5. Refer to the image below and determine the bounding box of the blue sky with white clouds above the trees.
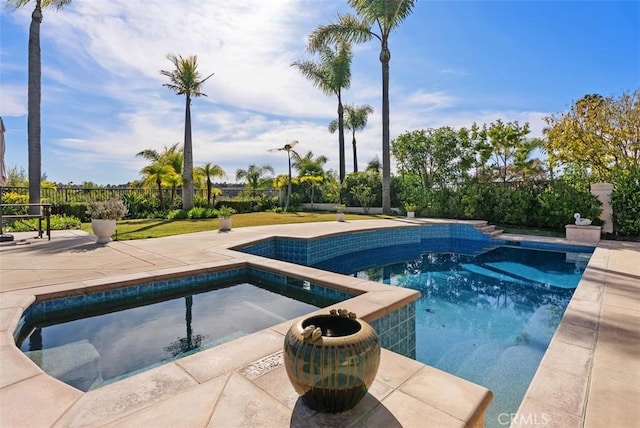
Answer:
[0,0,640,184]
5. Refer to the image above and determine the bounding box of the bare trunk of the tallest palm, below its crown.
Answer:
[380,43,391,215]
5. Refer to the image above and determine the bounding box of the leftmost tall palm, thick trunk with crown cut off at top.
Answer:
[7,0,71,214]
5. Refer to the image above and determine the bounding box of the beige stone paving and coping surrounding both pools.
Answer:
[0,219,640,426]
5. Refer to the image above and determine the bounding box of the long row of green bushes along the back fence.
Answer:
[2,170,640,238]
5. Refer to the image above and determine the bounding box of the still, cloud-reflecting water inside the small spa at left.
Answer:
[17,279,336,391]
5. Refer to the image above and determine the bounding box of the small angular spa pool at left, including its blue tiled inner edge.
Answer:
[16,269,351,391]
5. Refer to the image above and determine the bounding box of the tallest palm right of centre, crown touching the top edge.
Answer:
[308,0,416,214]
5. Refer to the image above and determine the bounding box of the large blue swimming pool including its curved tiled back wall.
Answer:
[240,225,593,426]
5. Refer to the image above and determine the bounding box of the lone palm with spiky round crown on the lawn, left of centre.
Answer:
[160,54,213,210]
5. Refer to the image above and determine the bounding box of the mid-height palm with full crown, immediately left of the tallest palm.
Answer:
[291,40,353,182]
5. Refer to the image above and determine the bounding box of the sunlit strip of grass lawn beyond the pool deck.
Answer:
[82,212,380,241]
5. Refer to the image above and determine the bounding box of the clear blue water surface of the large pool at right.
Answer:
[323,242,590,426]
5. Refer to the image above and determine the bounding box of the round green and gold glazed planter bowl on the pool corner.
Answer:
[284,309,380,413]
